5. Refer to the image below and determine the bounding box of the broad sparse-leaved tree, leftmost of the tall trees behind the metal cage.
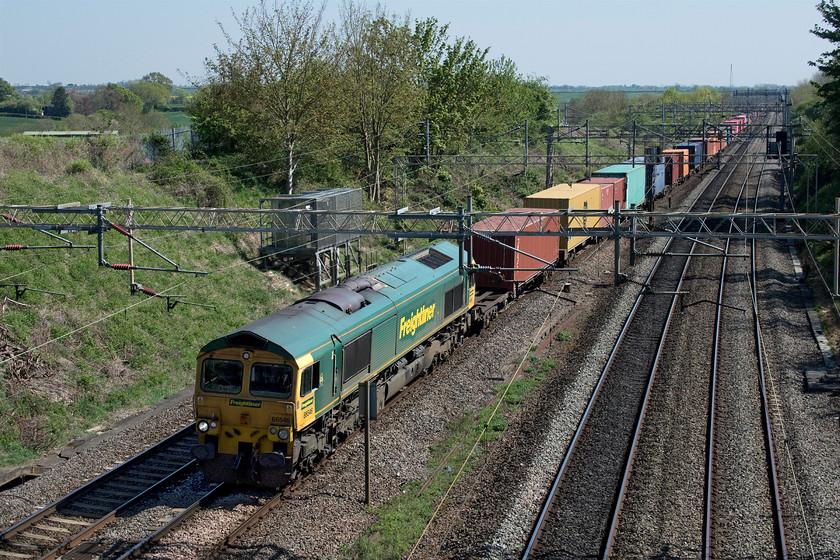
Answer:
[197,0,336,193]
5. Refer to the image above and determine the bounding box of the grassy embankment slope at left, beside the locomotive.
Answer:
[0,136,300,466]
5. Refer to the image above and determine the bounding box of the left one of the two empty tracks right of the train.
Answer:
[523,133,747,558]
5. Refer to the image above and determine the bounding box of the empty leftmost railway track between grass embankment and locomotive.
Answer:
[0,424,196,560]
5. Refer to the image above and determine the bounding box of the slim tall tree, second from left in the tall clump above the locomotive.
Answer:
[340,2,422,202]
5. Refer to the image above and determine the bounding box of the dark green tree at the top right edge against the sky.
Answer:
[809,0,840,134]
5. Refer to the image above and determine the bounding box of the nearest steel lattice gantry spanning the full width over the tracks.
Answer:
[0,205,840,241]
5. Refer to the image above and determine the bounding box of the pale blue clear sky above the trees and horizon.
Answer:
[0,0,829,87]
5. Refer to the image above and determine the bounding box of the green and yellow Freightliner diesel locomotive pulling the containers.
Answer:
[193,242,475,487]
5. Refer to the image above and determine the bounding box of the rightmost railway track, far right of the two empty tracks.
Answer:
[702,143,788,559]
